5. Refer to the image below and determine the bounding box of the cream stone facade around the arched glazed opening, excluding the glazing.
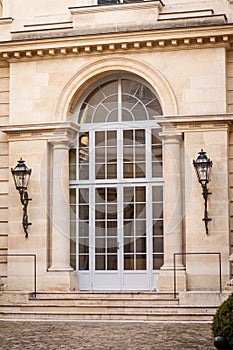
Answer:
[0,0,233,291]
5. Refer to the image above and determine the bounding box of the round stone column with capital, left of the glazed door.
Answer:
[49,124,79,271]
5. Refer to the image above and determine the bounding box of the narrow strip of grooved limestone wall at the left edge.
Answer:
[0,63,9,288]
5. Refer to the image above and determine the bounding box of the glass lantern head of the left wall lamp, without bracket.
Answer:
[11,158,32,191]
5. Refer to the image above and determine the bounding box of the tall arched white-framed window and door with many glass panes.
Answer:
[70,75,163,290]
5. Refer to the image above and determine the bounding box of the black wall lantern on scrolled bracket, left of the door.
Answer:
[11,158,32,238]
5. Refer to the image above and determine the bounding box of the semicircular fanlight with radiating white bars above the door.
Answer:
[74,75,162,124]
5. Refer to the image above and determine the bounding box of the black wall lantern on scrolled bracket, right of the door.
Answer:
[193,149,212,235]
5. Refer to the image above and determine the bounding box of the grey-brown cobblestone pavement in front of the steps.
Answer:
[0,321,215,350]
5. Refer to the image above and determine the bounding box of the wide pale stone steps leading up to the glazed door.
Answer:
[0,292,217,322]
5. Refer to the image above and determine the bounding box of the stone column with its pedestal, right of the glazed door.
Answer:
[158,131,185,291]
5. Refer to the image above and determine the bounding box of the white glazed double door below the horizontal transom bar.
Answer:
[76,182,162,291]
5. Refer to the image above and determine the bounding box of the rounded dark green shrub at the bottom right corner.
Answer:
[212,294,233,349]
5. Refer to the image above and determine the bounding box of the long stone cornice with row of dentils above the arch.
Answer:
[0,25,233,61]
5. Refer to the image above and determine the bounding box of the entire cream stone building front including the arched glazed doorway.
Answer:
[0,0,233,291]
